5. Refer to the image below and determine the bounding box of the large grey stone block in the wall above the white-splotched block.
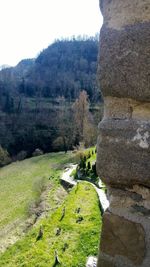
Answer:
[98,23,150,102]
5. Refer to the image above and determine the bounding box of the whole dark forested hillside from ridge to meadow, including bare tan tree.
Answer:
[0,35,101,161]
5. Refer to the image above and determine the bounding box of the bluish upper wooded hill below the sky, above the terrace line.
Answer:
[0,37,100,102]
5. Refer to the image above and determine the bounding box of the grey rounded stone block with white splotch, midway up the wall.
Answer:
[97,119,150,187]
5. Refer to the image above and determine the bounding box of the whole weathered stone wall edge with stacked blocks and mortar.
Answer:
[97,0,150,267]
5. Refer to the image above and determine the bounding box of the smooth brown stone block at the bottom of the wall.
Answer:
[101,213,146,266]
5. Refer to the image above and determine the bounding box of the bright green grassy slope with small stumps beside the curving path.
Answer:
[0,182,101,267]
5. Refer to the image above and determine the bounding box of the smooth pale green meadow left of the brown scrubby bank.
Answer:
[0,153,73,253]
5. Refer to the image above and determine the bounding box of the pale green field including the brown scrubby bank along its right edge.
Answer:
[0,152,77,251]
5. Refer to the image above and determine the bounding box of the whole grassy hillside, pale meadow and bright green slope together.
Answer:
[0,153,101,267]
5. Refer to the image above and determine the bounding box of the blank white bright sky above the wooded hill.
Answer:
[0,0,102,66]
